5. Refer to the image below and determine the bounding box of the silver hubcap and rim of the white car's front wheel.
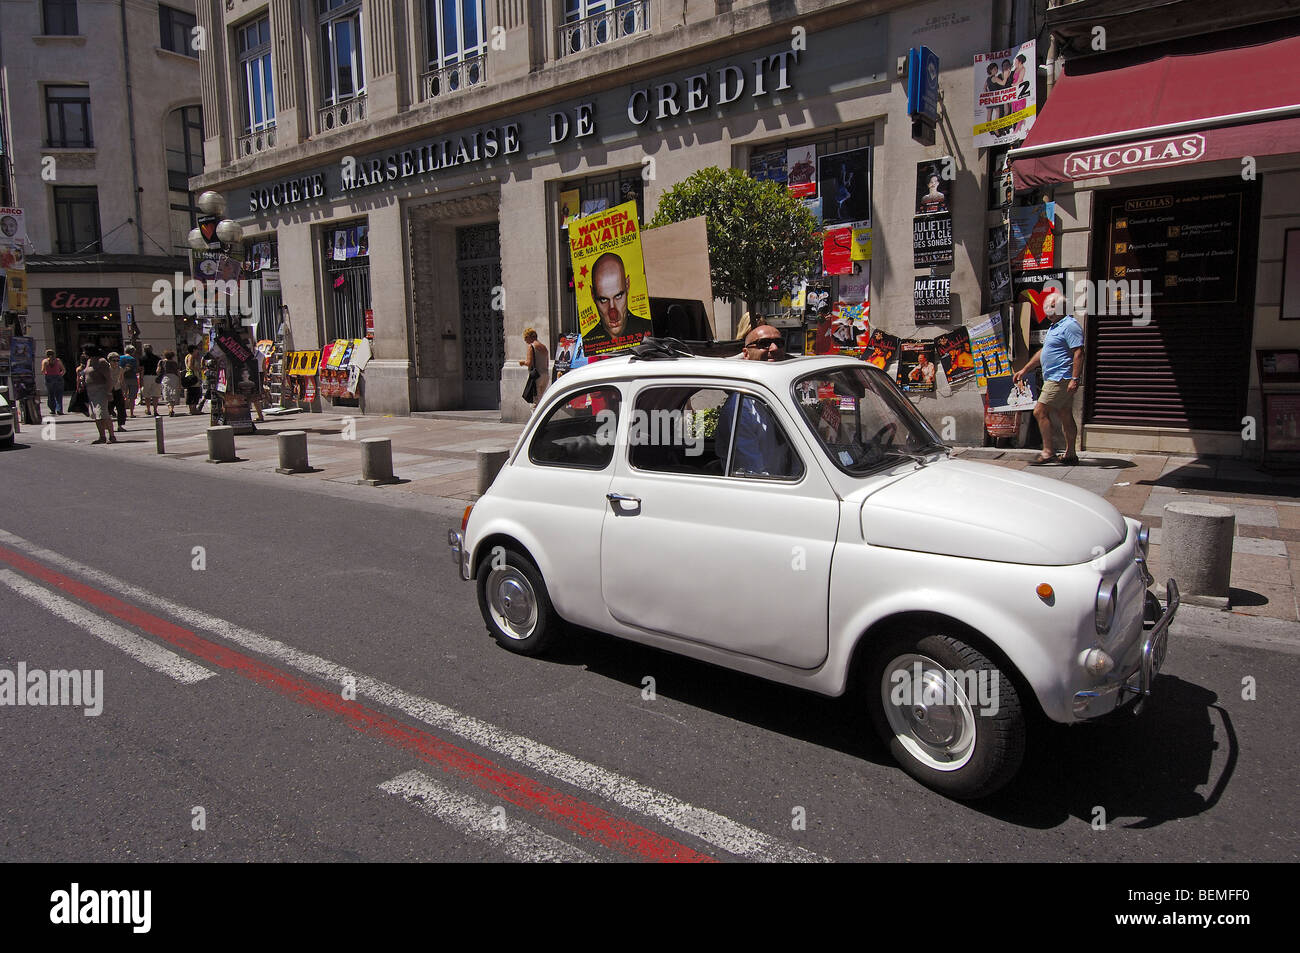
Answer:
[880,655,975,771]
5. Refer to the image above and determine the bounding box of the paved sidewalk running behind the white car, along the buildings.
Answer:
[18,411,1300,623]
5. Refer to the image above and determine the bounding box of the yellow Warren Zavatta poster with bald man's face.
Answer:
[569,202,651,360]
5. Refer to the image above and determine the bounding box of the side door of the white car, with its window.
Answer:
[601,381,840,668]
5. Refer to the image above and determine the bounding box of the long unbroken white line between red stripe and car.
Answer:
[0,529,828,863]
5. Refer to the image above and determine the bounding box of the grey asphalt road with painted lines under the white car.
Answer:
[0,443,1300,862]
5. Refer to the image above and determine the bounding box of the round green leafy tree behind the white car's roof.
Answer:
[649,165,822,321]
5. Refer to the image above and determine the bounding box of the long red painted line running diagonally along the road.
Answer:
[0,546,716,863]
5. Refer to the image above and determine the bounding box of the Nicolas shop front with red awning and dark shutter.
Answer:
[1011,31,1300,459]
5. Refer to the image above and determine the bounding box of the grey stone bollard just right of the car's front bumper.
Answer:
[1160,501,1236,608]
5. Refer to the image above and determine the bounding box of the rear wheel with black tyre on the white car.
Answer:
[478,547,560,655]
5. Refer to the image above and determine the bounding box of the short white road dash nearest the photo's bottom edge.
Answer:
[380,771,595,863]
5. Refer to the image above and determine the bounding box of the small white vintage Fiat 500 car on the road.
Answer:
[449,355,1178,798]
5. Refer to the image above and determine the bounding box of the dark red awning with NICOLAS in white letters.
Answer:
[1010,36,1300,189]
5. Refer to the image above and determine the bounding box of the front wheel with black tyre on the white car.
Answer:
[865,634,1026,800]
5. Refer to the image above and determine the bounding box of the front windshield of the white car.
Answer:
[794,365,945,476]
